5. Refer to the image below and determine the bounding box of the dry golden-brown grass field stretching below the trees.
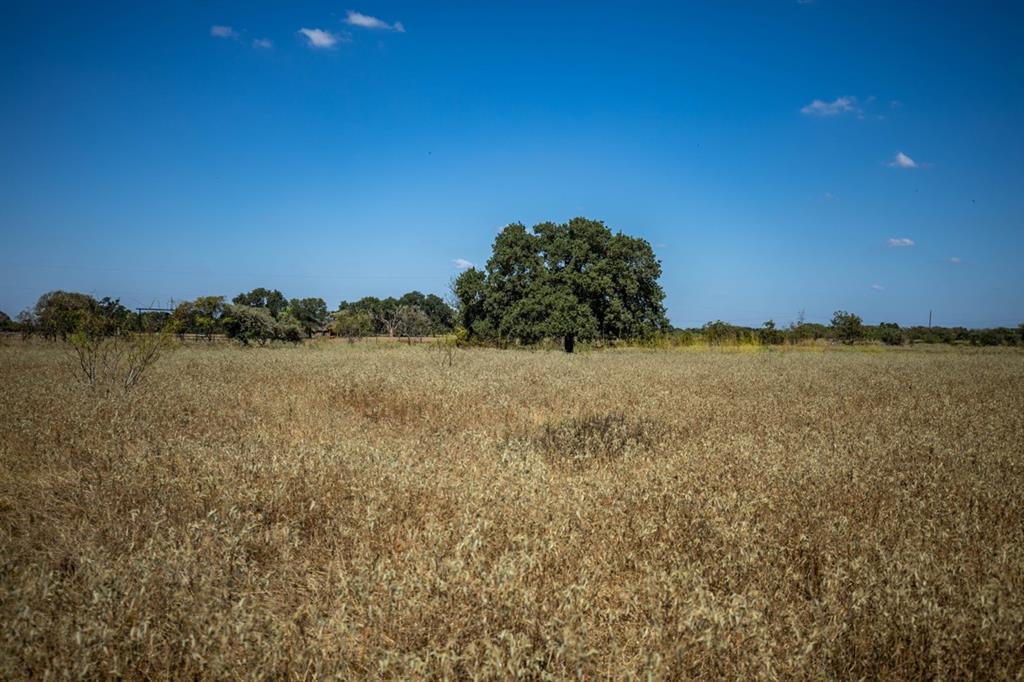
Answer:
[0,342,1024,679]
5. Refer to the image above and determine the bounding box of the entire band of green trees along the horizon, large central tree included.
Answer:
[0,284,1024,350]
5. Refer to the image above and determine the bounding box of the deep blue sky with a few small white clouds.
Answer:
[0,0,1024,326]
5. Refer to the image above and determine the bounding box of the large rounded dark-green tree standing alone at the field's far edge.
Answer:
[453,218,668,352]
